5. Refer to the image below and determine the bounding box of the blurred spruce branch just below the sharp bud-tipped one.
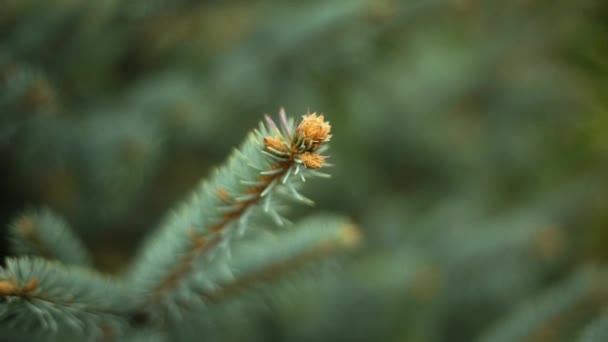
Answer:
[196,215,361,303]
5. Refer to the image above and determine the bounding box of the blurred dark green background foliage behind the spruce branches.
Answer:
[0,0,608,341]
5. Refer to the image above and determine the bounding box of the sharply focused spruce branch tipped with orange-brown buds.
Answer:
[129,109,338,316]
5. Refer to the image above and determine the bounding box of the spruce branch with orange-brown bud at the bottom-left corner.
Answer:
[0,257,135,337]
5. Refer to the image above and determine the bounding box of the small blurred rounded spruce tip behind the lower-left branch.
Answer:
[10,209,91,266]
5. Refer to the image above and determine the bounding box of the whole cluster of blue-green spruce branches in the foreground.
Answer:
[0,110,359,340]
